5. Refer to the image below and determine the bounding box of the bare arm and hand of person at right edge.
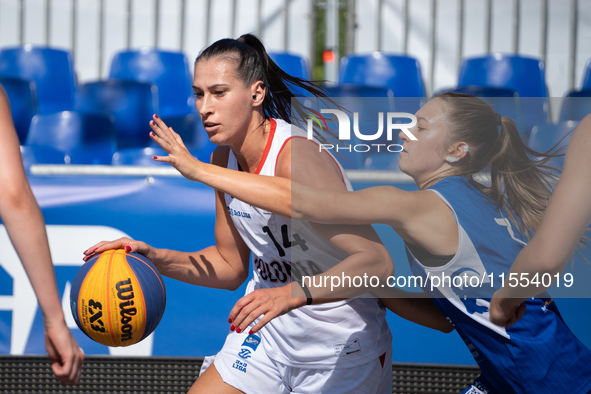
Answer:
[490,115,591,327]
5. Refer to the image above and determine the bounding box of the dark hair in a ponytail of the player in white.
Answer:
[195,34,334,142]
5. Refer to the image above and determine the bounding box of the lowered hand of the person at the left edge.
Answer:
[44,319,84,385]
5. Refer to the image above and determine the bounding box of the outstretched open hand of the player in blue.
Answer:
[150,114,202,181]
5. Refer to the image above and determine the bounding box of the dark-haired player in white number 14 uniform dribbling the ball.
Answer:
[86,35,449,394]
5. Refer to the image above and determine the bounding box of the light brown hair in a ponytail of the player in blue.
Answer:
[437,93,562,239]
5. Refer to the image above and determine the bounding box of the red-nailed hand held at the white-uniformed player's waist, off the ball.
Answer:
[228,285,306,334]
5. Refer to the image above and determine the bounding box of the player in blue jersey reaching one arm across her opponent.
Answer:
[154,94,591,394]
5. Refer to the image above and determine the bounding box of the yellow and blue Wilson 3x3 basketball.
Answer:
[70,249,166,346]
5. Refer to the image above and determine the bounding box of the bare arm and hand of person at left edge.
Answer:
[0,85,84,385]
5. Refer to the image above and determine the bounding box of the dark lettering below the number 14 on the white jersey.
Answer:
[254,257,323,283]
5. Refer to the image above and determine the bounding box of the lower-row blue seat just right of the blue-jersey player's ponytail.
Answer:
[527,120,579,168]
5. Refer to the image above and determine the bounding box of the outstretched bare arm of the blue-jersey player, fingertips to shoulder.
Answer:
[150,115,434,228]
